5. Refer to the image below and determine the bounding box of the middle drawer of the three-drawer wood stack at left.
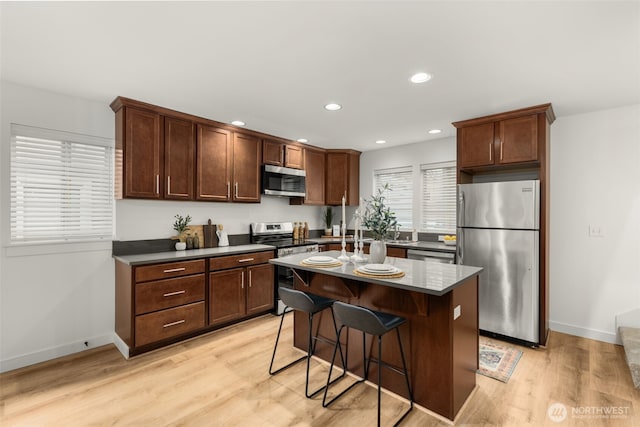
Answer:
[135,274,205,314]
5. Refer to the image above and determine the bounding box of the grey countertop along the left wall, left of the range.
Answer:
[114,245,276,265]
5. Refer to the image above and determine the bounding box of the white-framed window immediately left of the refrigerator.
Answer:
[420,162,457,234]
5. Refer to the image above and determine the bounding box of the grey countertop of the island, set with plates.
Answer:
[269,251,482,296]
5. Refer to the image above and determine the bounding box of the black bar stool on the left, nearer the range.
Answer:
[269,287,346,398]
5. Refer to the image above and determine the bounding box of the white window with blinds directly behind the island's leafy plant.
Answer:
[373,166,415,230]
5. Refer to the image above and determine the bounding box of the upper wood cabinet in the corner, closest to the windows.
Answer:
[325,150,360,206]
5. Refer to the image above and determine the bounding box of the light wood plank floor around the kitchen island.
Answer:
[0,315,640,427]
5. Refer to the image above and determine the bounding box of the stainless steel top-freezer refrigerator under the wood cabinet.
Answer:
[457,180,540,345]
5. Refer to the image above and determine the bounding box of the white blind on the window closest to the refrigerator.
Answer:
[420,163,456,233]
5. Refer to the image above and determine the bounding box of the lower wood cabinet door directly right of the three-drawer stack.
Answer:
[209,268,246,325]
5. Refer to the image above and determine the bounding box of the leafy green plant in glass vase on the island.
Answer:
[362,185,398,264]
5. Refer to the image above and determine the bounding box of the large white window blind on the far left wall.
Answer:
[10,124,114,244]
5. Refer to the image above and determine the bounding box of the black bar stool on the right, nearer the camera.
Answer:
[322,301,413,426]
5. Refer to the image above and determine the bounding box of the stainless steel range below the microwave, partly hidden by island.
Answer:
[249,222,318,314]
